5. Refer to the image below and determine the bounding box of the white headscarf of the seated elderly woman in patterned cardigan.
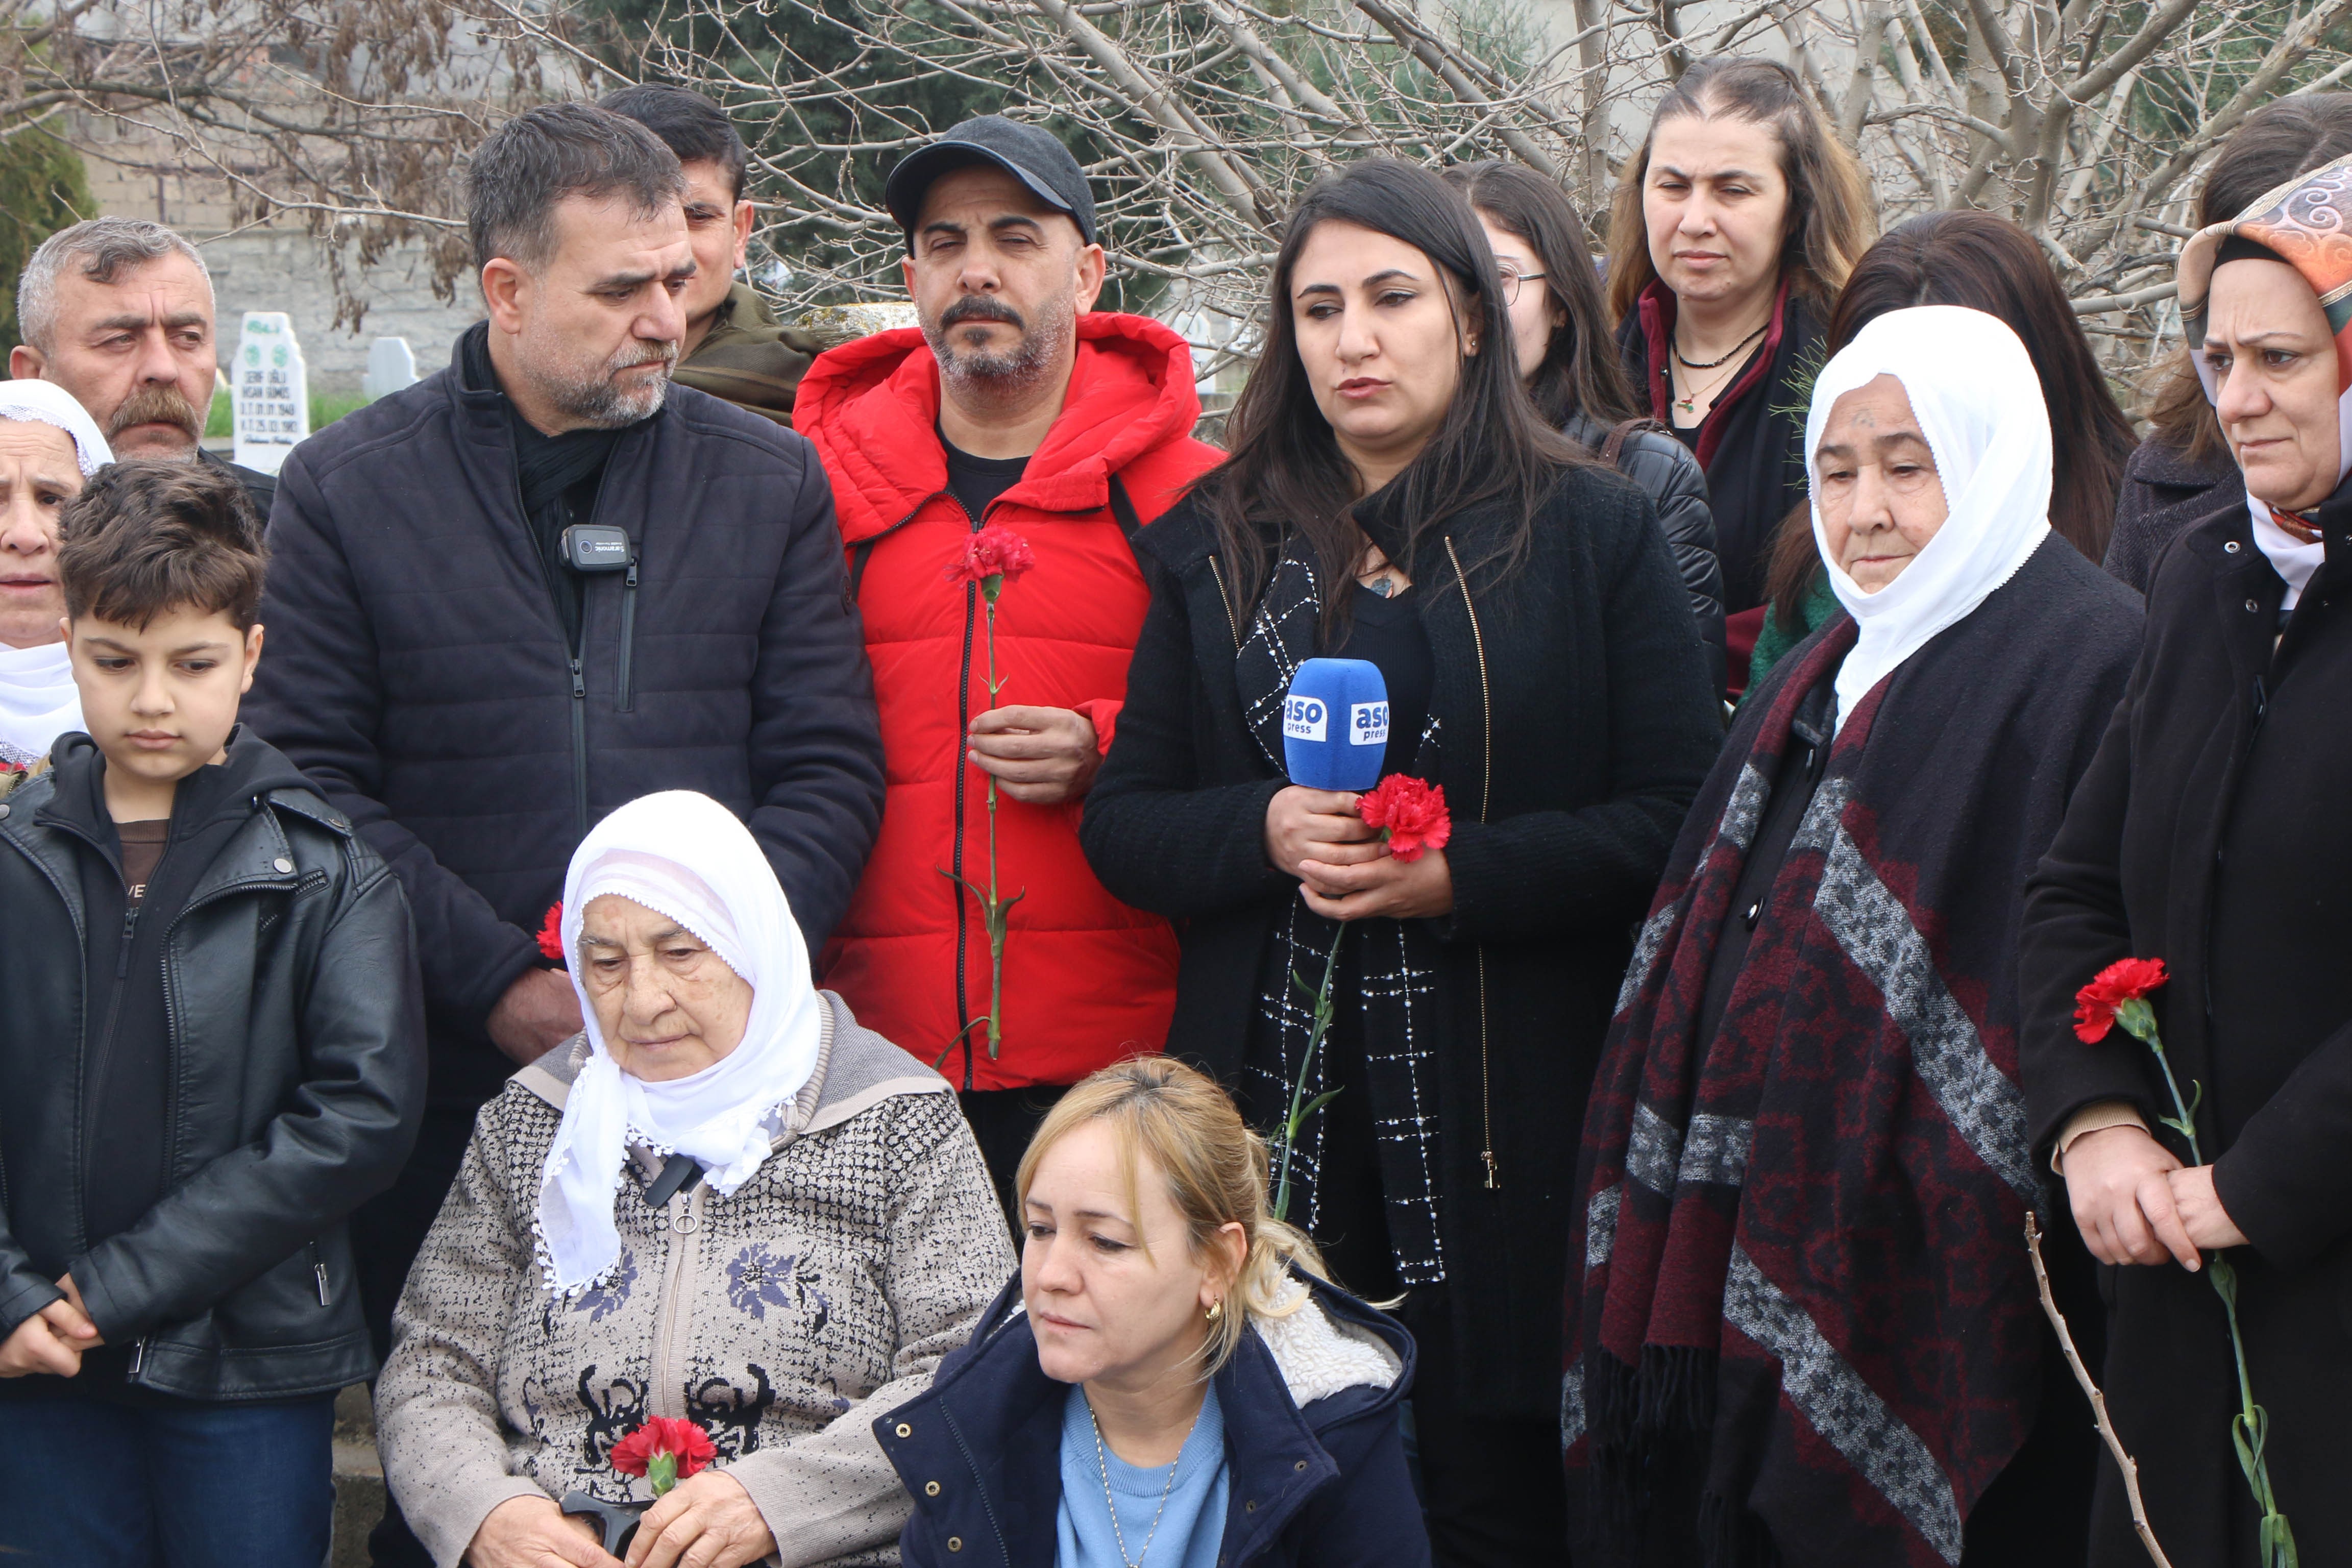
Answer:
[538,790,825,1295]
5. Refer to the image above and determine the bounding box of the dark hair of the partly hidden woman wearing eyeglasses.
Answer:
[1444,158,1649,428]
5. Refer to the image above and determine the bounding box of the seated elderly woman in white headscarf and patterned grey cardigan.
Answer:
[376,792,1014,1568]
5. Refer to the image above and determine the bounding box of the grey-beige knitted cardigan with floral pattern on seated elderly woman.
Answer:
[376,992,1014,1568]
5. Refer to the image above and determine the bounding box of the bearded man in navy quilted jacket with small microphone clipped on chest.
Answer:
[249,104,882,1401]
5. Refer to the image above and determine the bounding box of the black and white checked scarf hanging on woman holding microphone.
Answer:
[1235,538,1447,1286]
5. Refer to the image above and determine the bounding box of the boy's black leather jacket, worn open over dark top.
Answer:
[0,731,426,1401]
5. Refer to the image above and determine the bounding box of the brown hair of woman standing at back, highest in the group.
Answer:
[1609,54,1877,322]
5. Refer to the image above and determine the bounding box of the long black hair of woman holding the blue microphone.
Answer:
[1192,158,1583,632]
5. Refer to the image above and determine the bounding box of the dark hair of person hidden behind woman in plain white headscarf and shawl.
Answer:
[1764,209,2140,630]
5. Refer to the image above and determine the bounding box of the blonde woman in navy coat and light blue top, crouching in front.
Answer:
[875,1056,1430,1568]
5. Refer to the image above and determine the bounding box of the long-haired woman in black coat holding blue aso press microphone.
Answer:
[1082,160,1719,1563]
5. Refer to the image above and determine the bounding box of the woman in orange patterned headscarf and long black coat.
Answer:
[2020,158,2352,1568]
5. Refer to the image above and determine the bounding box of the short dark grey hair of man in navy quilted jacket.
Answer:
[465,104,687,271]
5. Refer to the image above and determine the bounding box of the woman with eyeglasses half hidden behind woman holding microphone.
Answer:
[1444,160,1724,694]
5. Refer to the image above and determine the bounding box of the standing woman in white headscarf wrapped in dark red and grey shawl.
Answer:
[1562,306,2140,1568]
